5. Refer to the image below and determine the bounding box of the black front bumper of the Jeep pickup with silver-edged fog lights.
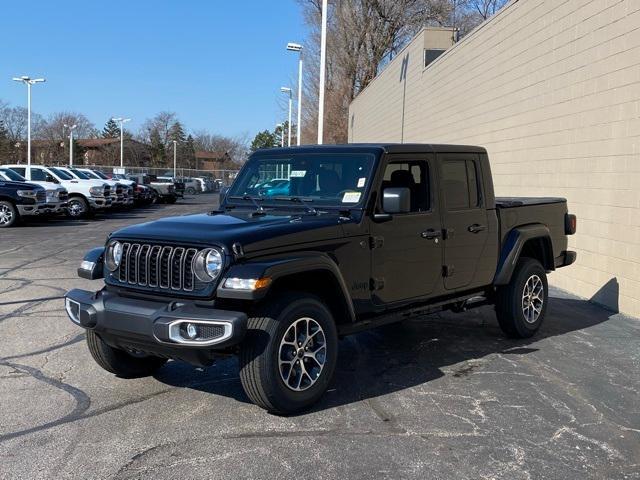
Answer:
[65,289,247,365]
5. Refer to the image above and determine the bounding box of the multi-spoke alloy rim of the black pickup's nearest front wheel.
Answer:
[278,317,327,392]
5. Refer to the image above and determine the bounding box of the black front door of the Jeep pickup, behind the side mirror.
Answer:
[371,154,442,305]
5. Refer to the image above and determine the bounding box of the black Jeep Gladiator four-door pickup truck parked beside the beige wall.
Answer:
[65,144,576,414]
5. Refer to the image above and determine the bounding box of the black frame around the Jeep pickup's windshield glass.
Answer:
[221,149,381,211]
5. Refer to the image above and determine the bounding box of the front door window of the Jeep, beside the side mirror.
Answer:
[382,161,431,213]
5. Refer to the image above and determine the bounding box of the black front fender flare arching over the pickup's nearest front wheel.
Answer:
[216,252,356,321]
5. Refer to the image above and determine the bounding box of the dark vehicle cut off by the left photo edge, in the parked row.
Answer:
[0,176,48,228]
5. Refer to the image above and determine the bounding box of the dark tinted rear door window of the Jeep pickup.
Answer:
[442,160,480,210]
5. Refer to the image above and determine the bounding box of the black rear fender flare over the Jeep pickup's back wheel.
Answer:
[493,224,555,285]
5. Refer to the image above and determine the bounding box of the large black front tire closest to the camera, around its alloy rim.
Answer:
[240,293,338,415]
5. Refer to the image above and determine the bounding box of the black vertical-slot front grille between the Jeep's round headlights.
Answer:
[113,243,199,292]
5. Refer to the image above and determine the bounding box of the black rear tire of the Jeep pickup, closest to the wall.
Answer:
[496,257,549,338]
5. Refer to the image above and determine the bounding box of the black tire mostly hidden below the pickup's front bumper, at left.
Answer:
[87,330,167,378]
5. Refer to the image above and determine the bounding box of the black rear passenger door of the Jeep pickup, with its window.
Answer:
[438,153,488,290]
